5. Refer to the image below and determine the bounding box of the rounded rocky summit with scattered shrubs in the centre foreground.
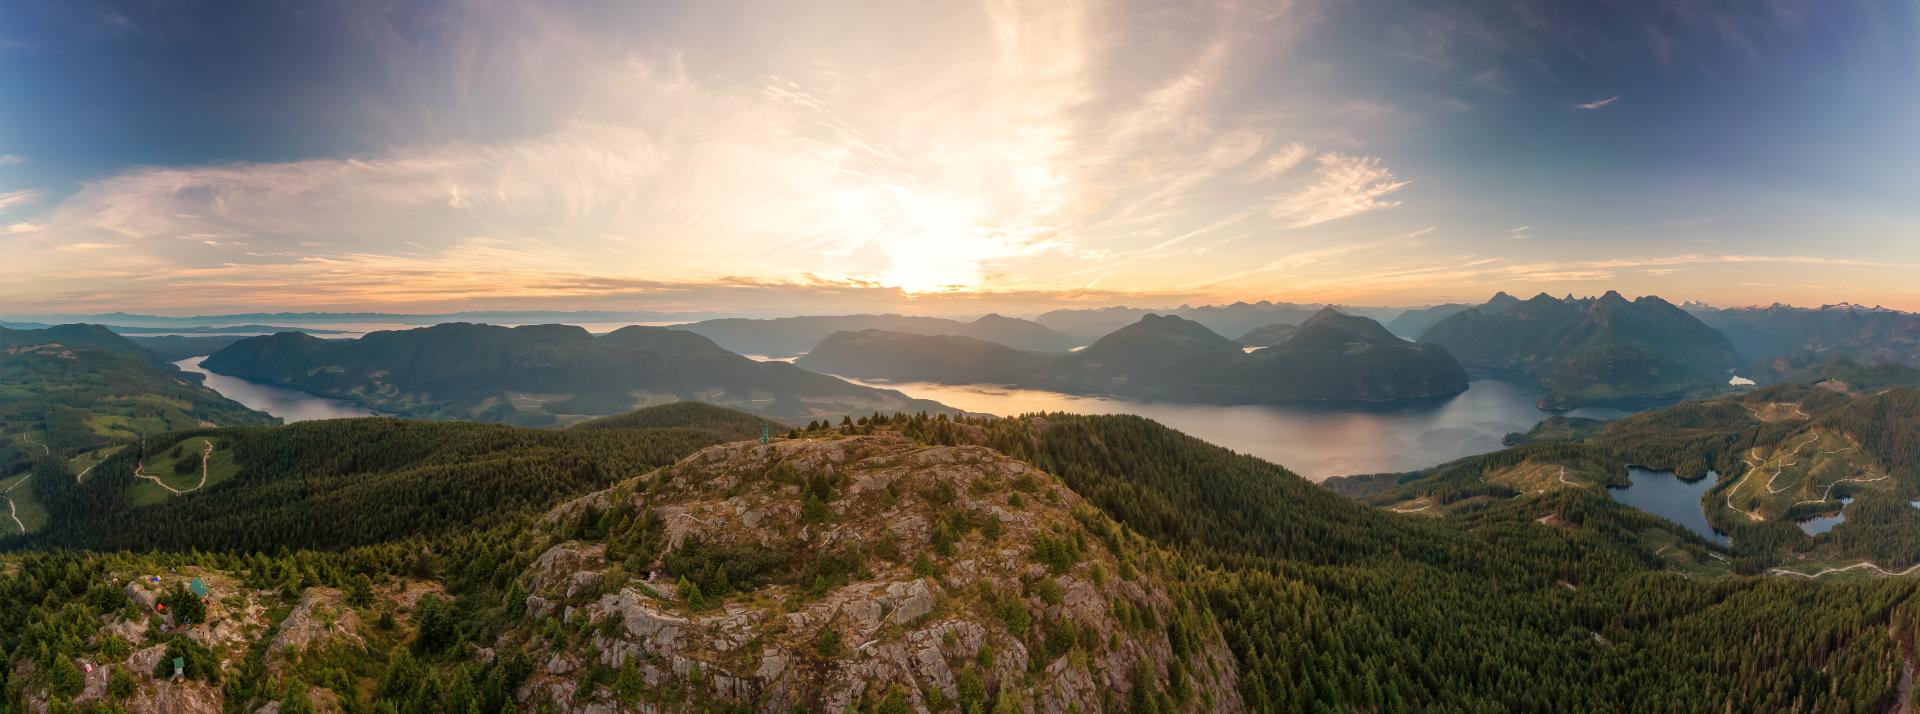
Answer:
[495,436,1240,712]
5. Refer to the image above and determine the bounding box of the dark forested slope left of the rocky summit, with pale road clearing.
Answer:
[13,405,785,551]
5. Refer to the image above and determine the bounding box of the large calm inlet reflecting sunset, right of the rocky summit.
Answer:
[837,380,1624,480]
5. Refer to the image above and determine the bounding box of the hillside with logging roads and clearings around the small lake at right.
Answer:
[1327,378,1920,570]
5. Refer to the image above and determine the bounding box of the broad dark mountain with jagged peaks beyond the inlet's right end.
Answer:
[1421,290,1738,409]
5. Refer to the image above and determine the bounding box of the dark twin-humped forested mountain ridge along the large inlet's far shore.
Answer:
[799,309,1467,403]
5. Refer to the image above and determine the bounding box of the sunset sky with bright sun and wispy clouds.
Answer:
[0,0,1920,315]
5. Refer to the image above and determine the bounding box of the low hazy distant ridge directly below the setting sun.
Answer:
[674,315,1079,357]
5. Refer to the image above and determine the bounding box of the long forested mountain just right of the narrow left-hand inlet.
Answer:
[202,322,950,426]
